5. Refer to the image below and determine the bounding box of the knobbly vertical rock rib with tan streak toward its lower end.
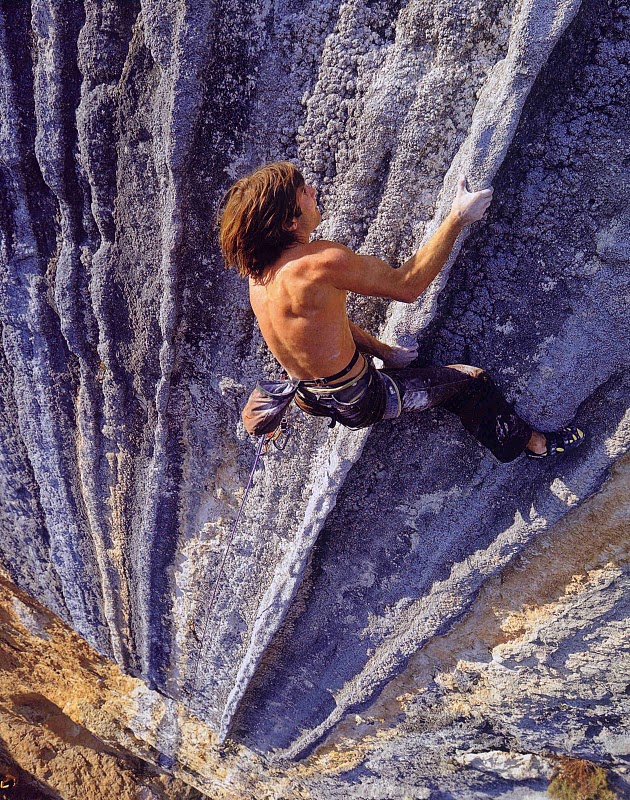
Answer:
[74,3,143,669]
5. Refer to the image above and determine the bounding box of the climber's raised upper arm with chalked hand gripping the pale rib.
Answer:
[322,175,493,303]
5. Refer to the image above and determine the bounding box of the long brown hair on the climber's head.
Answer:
[217,161,304,278]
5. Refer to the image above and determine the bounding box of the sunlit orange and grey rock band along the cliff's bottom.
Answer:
[0,457,630,800]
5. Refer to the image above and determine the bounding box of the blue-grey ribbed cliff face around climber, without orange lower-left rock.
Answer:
[0,0,630,798]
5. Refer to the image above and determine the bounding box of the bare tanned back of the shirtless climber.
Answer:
[249,242,360,379]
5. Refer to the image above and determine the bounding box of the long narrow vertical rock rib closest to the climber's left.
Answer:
[131,2,222,681]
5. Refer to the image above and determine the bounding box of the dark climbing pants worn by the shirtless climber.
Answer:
[297,363,532,463]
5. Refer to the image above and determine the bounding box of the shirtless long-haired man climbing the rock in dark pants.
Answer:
[220,162,584,462]
